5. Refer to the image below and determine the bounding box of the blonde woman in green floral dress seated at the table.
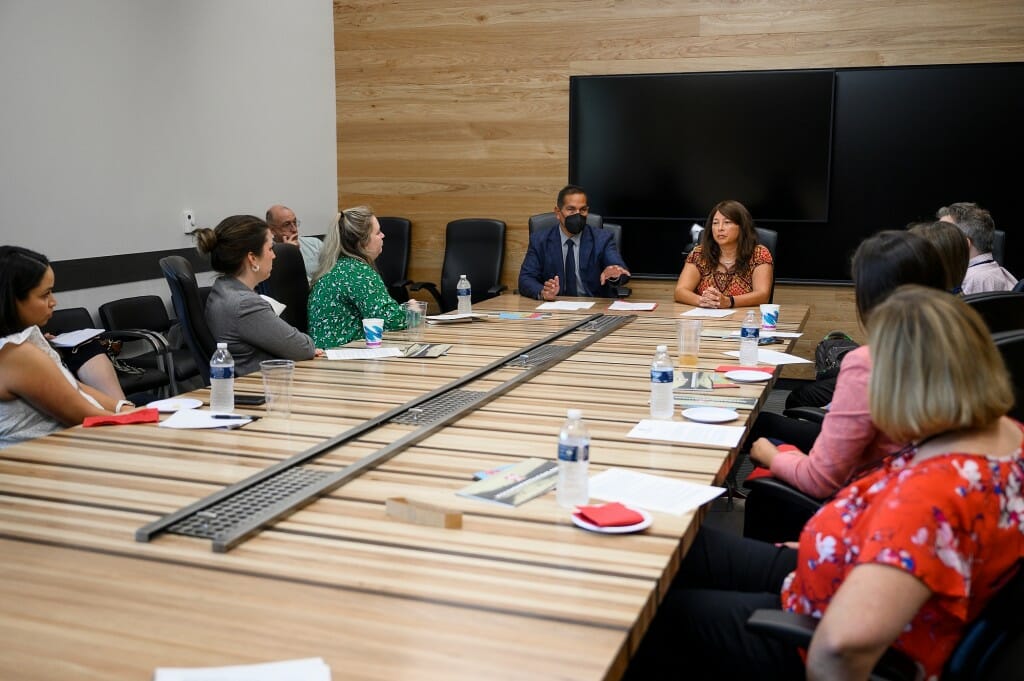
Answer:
[309,206,406,348]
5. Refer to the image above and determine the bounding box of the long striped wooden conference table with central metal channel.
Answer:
[0,294,808,681]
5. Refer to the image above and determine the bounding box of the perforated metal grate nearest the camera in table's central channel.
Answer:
[168,467,331,539]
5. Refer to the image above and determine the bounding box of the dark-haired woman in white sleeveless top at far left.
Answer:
[0,246,130,448]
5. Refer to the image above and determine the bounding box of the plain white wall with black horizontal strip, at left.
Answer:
[0,0,338,317]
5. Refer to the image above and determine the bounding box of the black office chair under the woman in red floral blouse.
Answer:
[746,566,1024,681]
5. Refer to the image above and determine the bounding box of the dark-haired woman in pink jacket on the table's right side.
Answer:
[751,230,946,499]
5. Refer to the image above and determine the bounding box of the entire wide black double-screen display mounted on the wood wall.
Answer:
[569,62,1024,282]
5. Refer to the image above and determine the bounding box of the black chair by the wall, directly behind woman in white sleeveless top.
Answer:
[42,307,177,396]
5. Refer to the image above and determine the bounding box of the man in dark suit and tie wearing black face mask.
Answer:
[519,184,630,300]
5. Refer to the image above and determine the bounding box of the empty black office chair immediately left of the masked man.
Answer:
[409,218,506,312]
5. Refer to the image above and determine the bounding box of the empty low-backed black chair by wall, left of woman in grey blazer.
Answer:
[99,296,199,392]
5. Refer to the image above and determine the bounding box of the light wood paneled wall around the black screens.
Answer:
[334,0,1024,315]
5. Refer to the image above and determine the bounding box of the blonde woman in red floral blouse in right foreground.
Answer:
[627,286,1024,679]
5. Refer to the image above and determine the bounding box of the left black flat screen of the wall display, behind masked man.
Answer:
[569,71,835,223]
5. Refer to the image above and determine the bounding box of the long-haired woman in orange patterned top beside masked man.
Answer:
[675,199,774,307]
